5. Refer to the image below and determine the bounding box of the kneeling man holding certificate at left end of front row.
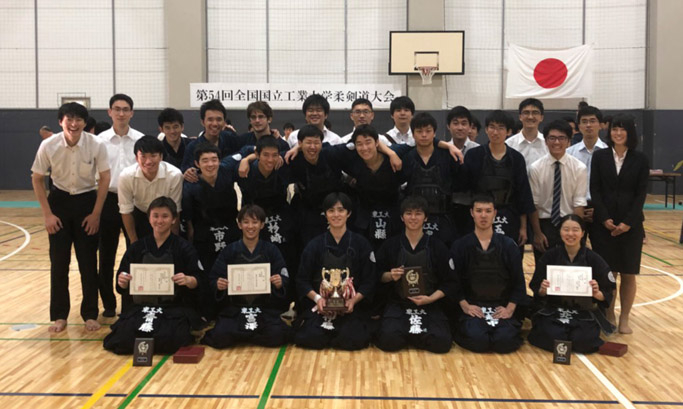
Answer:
[104,196,204,355]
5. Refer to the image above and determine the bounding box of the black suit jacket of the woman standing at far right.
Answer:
[590,148,650,227]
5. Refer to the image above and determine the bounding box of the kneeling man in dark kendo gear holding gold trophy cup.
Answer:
[294,192,376,350]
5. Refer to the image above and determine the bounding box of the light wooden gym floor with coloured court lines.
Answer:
[0,191,683,409]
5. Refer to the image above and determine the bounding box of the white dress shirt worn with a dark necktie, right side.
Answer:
[529,153,588,219]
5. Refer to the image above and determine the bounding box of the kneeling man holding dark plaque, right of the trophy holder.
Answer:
[375,196,455,353]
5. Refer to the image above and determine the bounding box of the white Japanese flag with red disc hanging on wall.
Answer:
[505,44,593,98]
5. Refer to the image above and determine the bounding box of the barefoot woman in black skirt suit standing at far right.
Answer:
[590,114,650,334]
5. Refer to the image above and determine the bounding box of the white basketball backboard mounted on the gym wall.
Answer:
[389,31,465,75]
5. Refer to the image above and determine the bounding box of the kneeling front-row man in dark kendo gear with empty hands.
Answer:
[451,196,526,353]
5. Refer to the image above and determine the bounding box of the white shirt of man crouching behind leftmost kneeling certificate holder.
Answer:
[119,162,183,214]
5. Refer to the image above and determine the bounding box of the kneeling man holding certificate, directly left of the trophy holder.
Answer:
[202,205,292,348]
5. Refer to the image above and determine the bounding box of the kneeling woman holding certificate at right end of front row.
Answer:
[528,214,616,353]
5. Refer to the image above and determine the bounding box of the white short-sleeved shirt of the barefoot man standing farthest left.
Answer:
[31,132,109,195]
